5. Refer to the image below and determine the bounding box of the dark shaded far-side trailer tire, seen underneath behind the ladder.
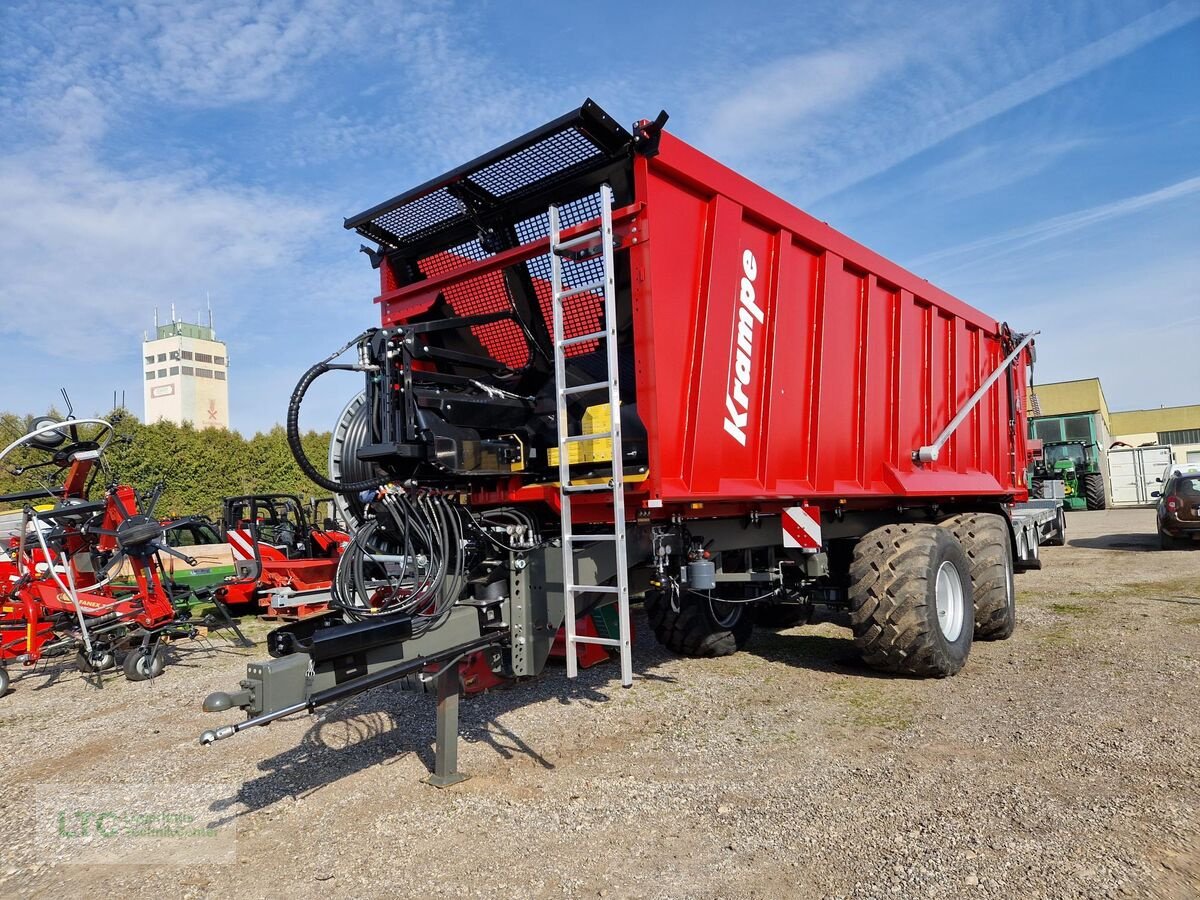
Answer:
[643,589,754,656]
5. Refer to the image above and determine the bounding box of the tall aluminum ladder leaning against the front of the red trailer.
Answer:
[550,185,634,688]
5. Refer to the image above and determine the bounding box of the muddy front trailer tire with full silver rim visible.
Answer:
[850,524,974,678]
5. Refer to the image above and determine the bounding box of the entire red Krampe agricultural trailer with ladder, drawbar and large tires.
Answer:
[203,101,1061,784]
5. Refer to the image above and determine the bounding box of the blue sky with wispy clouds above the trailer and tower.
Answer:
[0,0,1200,432]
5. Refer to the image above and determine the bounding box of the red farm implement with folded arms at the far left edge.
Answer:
[0,418,245,695]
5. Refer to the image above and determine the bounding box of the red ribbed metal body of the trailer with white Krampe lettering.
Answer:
[364,103,1027,518]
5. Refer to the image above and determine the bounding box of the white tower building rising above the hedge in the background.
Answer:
[142,313,229,428]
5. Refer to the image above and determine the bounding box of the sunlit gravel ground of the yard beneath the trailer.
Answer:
[0,510,1200,898]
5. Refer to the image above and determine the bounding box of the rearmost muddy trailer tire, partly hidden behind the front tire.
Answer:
[941,512,1016,641]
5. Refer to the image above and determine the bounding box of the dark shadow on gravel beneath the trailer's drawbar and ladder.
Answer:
[202,610,676,827]
